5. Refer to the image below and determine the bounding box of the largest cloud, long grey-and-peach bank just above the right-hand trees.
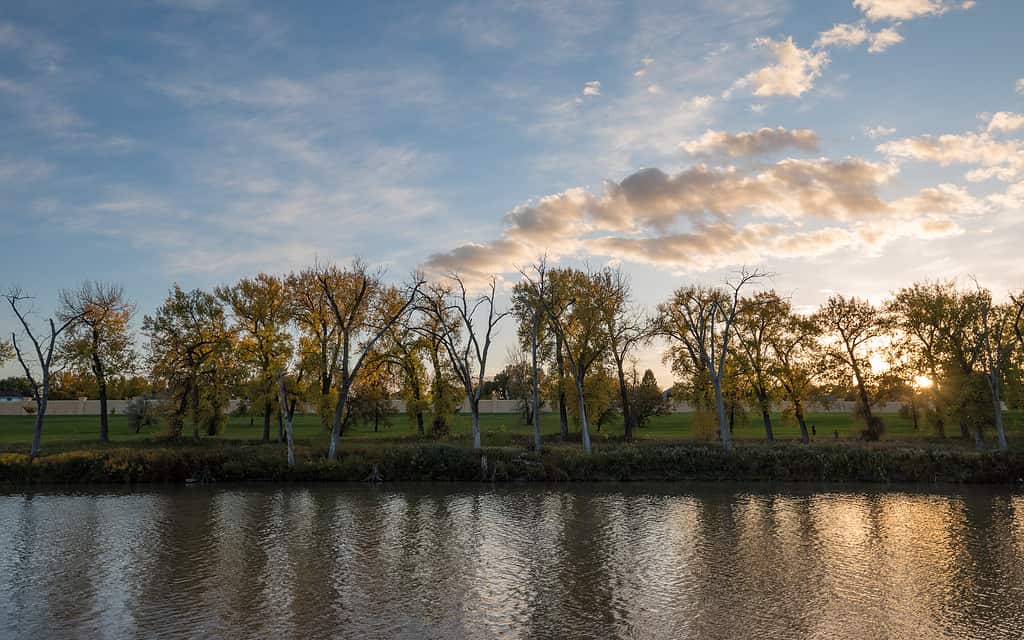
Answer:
[425,153,970,278]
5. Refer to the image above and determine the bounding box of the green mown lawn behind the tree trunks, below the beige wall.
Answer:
[0,412,1024,451]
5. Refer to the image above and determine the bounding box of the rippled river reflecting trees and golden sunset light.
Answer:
[0,483,1024,640]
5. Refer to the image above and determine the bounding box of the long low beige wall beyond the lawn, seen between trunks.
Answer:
[0,398,900,416]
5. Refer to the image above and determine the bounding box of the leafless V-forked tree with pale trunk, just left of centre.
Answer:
[420,273,509,450]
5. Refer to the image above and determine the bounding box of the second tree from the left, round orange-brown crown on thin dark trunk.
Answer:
[57,281,136,442]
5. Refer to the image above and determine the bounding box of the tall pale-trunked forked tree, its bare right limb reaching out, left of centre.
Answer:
[316,260,426,460]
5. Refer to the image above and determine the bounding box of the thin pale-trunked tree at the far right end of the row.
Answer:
[974,281,1024,451]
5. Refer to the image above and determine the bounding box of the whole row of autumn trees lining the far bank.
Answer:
[6,259,1024,459]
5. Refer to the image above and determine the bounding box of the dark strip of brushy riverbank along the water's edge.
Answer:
[0,442,1024,485]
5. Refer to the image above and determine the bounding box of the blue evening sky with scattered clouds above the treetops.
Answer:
[0,0,1024,378]
